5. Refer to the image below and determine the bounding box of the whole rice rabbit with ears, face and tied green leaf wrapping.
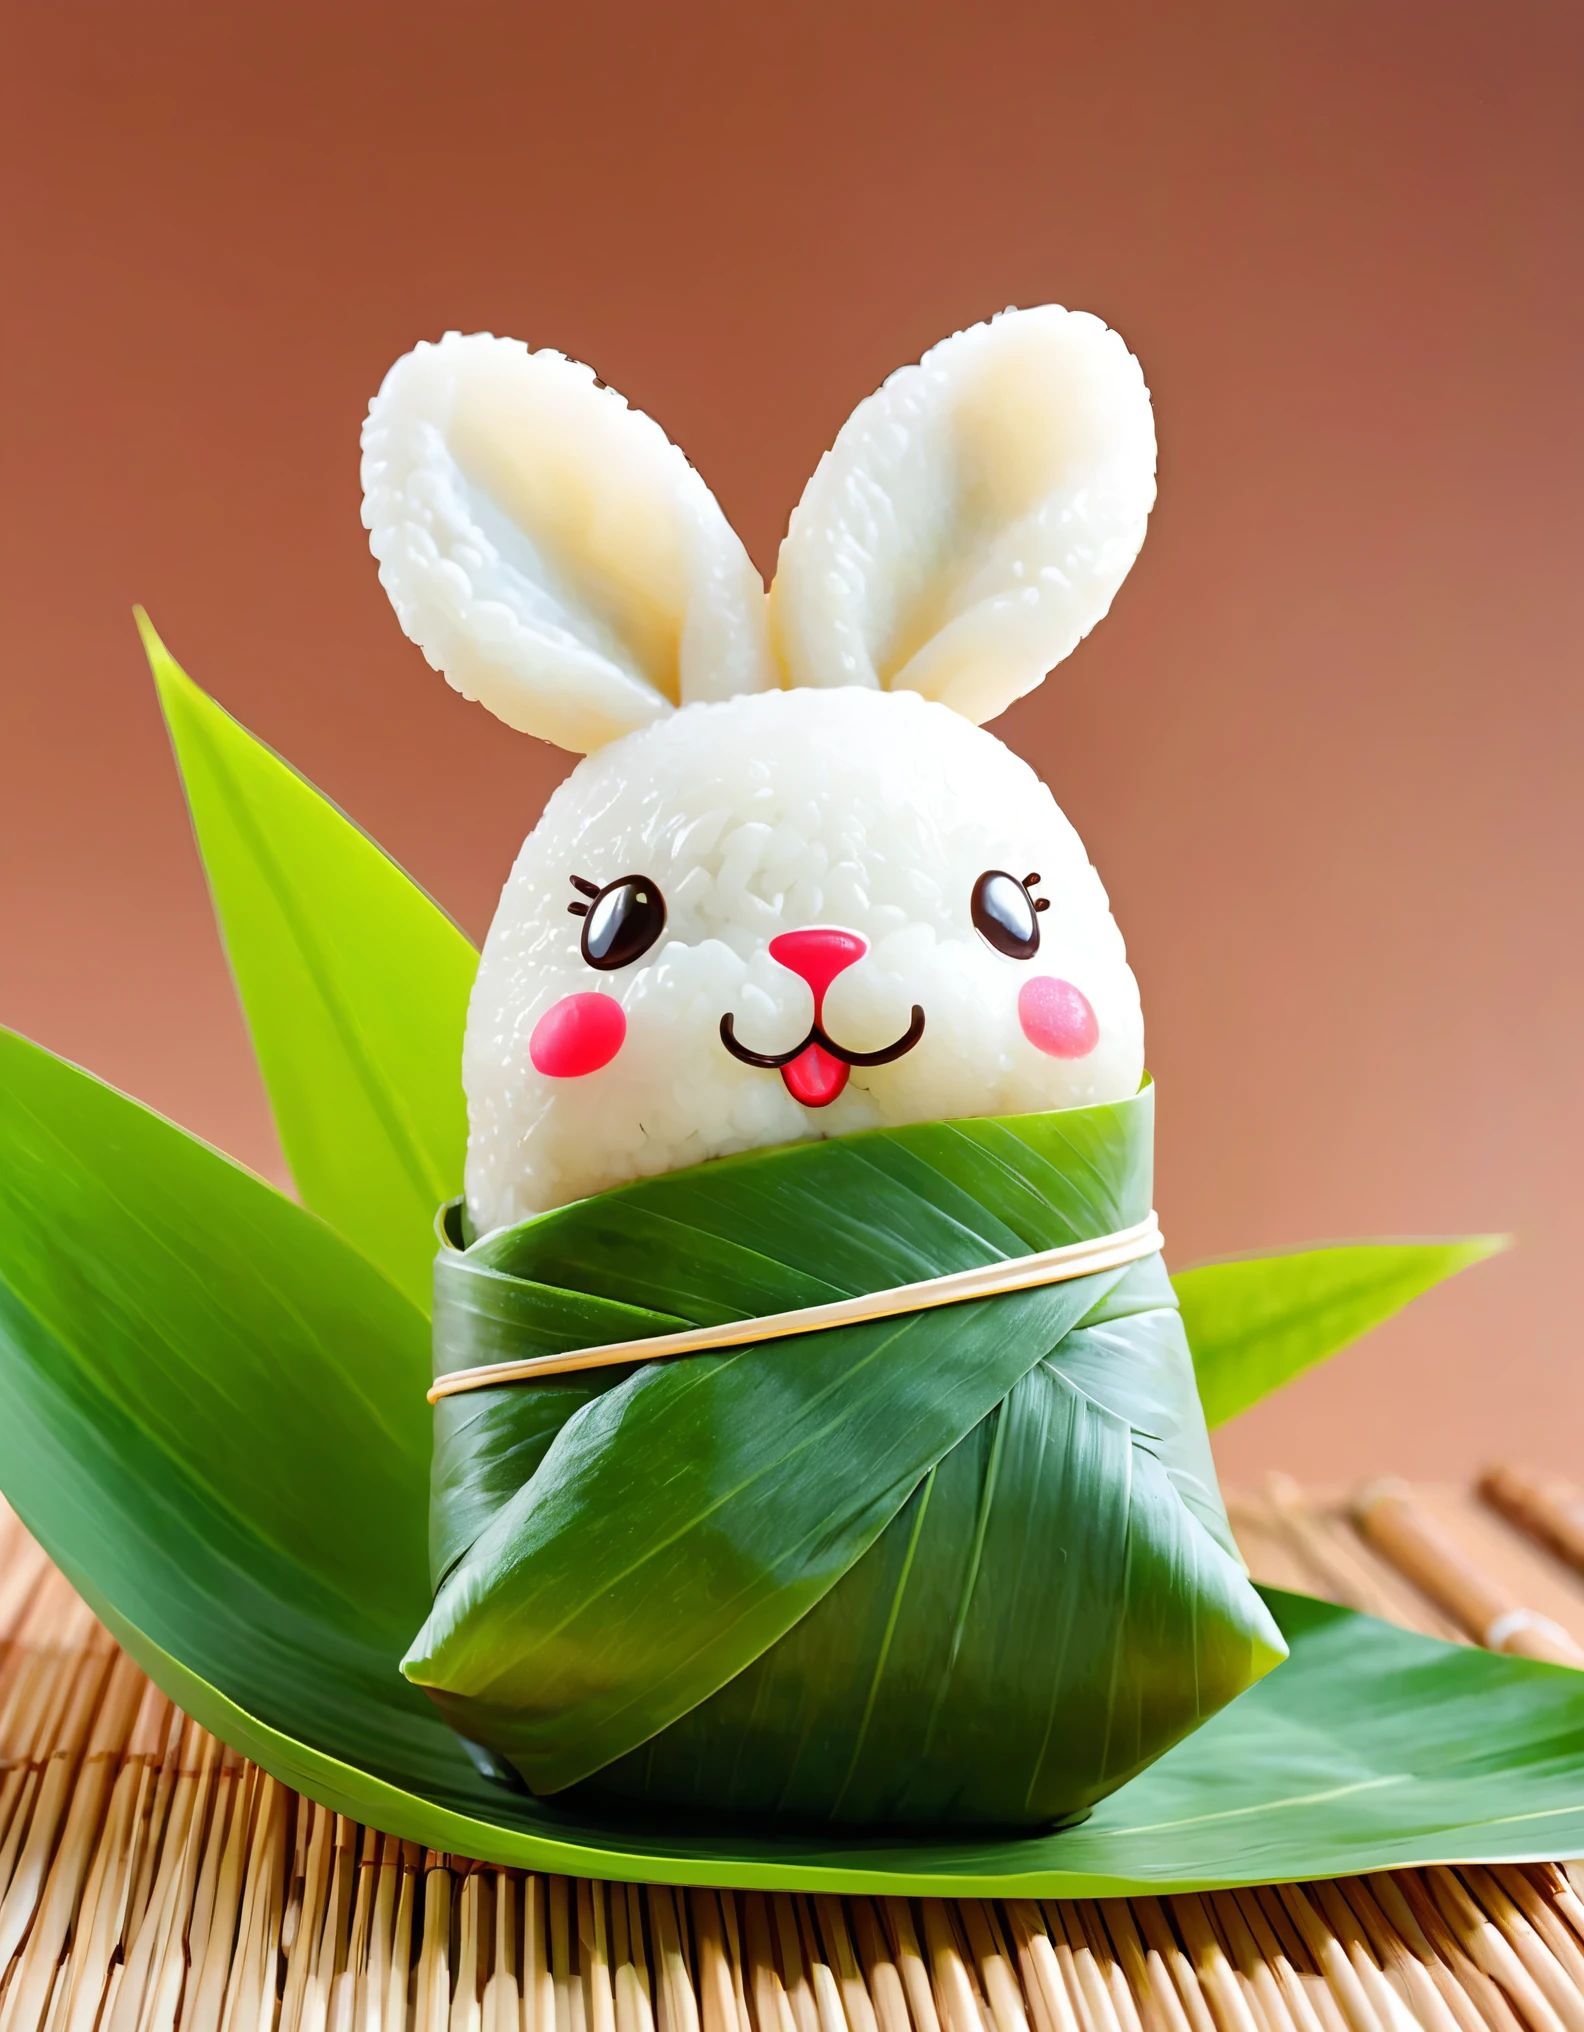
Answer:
[364,321,1283,1829]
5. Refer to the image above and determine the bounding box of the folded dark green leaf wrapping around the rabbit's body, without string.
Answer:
[404,1087,1285,1827]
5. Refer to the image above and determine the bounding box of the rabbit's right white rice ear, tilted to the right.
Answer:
[770,305,1156,721]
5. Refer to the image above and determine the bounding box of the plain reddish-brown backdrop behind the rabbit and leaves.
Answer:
[0,0,1584,1473]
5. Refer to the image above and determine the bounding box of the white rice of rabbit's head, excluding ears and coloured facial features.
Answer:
[463,687,1143,1233]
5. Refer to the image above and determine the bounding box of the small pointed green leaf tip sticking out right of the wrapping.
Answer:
[1172,1235,1507,1426]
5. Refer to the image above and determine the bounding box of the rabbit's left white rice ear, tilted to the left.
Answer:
[364,331,776,754]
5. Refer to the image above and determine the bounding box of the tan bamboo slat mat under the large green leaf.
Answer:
[0,1477,1584,2032]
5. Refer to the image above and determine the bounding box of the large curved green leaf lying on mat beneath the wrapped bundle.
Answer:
[0,1034,1584,1898]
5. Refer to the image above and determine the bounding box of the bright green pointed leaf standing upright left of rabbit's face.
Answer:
[138,610,477,1313]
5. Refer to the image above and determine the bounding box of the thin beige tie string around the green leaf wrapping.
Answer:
[428,1209,1162,1404]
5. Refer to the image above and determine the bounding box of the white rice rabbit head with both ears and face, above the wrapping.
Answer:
[364,305,1156,1231]
